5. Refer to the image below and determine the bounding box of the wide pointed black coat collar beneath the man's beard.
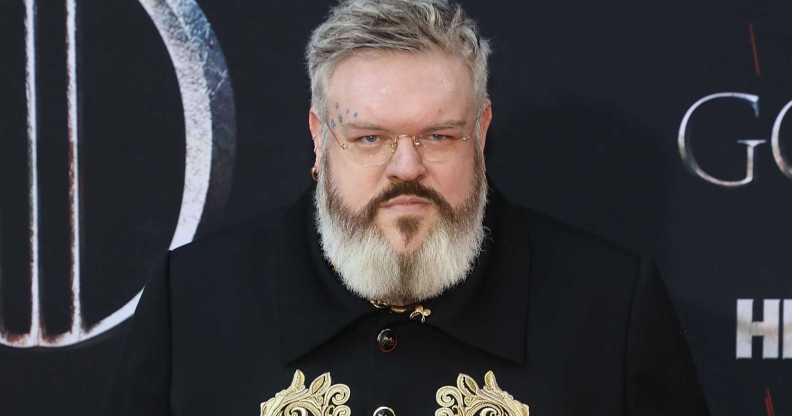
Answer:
[272,184,530,363]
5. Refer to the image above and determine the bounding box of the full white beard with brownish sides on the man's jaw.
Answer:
[314,156,487,305]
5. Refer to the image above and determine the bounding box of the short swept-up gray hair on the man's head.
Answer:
[305,0,491,117]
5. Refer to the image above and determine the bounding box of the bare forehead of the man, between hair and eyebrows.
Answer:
[327,50,473,128]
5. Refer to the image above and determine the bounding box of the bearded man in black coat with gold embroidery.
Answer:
[109,0,706,416]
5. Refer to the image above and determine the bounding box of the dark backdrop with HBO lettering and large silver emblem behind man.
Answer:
[0,0,792,416]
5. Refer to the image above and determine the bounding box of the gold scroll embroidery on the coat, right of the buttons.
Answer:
[435,371,528,416]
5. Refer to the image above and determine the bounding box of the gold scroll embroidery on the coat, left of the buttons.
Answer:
[261,370,352,416]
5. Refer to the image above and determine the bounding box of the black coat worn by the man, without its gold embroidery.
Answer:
[107,188,707,416]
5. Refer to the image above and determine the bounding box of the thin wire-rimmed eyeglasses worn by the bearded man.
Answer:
[325,123,470,166]
